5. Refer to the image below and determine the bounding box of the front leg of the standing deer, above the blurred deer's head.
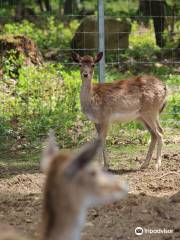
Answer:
[95,123,108,169]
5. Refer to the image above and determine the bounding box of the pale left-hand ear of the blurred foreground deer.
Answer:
[40,130,59,172]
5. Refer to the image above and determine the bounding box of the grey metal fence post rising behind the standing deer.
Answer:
[98,0,105,83]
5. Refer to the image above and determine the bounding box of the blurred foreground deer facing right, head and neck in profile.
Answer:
[0,134,128,240]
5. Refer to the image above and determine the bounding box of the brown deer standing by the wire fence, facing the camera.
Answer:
[72,52,167,170]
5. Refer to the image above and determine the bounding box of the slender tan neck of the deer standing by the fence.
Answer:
[80,78,92,112]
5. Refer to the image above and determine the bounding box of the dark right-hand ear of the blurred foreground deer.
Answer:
[65,138,102,177]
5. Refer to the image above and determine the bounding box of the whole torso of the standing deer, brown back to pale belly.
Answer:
[85,76,166,122]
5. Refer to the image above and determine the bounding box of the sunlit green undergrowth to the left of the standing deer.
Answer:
[0,56,95,147]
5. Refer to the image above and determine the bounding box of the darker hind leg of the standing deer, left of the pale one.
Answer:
[141,120,157,169]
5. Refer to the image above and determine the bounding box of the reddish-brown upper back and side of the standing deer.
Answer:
[93,76,166,105]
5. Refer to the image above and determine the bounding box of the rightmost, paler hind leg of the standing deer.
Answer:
[143,116,163,170]
